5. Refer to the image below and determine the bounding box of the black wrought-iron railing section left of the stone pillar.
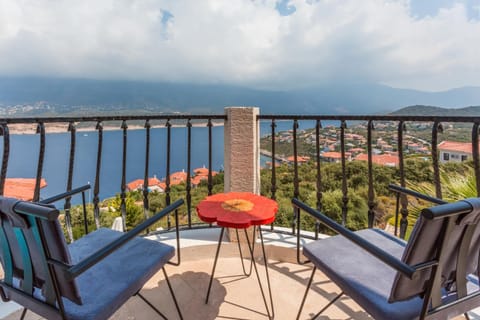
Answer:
[0,114,226,241]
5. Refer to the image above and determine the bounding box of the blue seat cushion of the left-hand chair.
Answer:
[64,228,175,320]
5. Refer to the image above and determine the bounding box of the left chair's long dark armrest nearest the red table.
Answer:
[66,199,184,279]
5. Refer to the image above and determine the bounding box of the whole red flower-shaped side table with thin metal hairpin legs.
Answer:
[197,192,278,319]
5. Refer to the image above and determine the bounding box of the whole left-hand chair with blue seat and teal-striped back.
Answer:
[0,189,183,319]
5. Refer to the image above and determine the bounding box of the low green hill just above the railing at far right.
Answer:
[390,105,480,117]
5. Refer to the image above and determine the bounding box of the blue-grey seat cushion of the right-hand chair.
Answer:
[303,229,422,320]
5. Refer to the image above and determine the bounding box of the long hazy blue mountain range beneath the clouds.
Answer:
[0,77,480,115]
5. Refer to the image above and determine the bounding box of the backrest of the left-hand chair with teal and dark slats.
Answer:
[0,197,82,306]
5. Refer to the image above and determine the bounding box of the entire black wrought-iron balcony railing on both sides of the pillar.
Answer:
[0,114,480,244]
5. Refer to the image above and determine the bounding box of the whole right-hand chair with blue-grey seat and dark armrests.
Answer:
[292,198,480,320]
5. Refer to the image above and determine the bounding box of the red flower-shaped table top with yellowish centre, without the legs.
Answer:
[197,192,278,228]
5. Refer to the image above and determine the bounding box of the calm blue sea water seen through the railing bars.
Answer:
[0,121,338,204]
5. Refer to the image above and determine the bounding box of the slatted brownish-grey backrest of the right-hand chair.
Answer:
[389,198,480,302]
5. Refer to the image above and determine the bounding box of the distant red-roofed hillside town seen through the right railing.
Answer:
[261,122,472,167]
